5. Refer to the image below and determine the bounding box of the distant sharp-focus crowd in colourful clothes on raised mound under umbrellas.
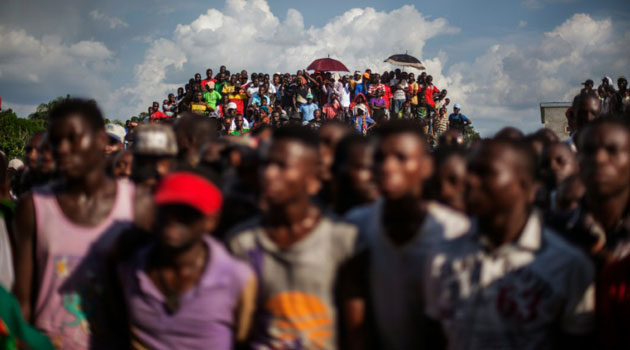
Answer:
[141,66,471,145]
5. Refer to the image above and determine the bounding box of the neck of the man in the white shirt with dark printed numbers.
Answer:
[479,206,531,247]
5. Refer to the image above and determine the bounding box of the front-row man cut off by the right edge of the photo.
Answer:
[566,119,630,267]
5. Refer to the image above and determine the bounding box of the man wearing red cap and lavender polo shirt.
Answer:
[118,172,256,350]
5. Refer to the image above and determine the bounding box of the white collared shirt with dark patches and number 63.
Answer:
[424,212,595,349]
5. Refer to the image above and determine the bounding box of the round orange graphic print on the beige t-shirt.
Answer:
[264,291,334,350]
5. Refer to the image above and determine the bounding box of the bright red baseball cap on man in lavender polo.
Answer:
[153,171,223,215]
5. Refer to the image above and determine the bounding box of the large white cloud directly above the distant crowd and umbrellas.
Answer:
[116,0,458,119]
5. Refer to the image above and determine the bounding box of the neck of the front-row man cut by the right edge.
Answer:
[585,188,630,231]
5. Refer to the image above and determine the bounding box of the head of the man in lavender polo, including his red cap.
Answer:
[153,172,223,252]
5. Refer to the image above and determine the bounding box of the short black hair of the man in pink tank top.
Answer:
[48,98,105,131]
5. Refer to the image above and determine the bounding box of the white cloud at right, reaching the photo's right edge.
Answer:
[447,14,630,134]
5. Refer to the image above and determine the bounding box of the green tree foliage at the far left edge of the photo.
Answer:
[0,109,45,159]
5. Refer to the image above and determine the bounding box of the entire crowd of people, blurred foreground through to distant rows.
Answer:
[0,68,630,350]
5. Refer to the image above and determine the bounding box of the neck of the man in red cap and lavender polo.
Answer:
[156,239,208,273]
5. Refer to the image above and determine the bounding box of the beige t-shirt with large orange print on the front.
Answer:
[228,217,357,349]
